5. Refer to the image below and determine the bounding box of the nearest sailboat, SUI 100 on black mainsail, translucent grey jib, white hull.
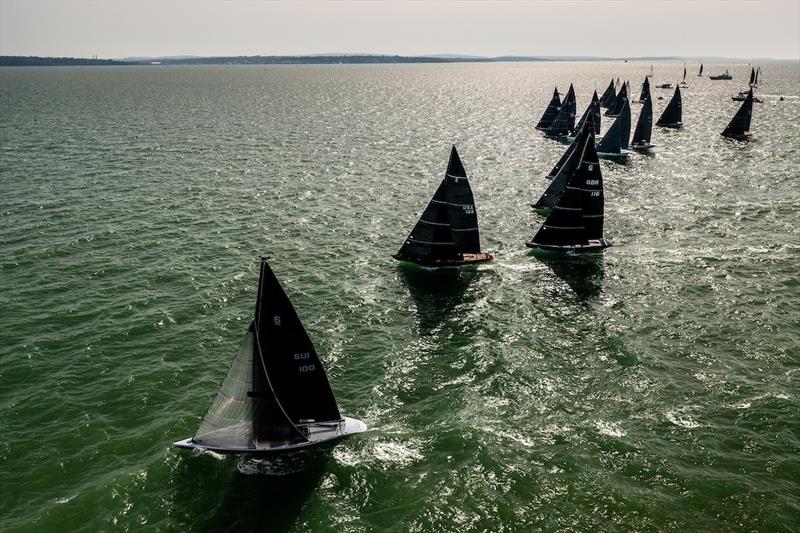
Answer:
[175,258,367,454]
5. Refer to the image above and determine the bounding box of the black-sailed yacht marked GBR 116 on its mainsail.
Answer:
[525,119,612,253]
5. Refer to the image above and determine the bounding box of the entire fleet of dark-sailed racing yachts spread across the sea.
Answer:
[174,63,760,456]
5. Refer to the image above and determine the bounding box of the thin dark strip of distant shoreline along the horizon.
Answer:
[0,54,790,67]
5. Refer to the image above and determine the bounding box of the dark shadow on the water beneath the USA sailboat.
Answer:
[398,264,481,333]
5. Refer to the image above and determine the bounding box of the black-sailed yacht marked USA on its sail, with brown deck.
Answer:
[392,146,494,267]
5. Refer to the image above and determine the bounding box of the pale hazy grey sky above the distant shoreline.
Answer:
[0,0,800,59]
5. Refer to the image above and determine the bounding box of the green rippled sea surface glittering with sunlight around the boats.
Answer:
[0,62,800,532]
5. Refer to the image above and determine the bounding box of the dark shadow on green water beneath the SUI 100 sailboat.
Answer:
[173,450,331,531]
